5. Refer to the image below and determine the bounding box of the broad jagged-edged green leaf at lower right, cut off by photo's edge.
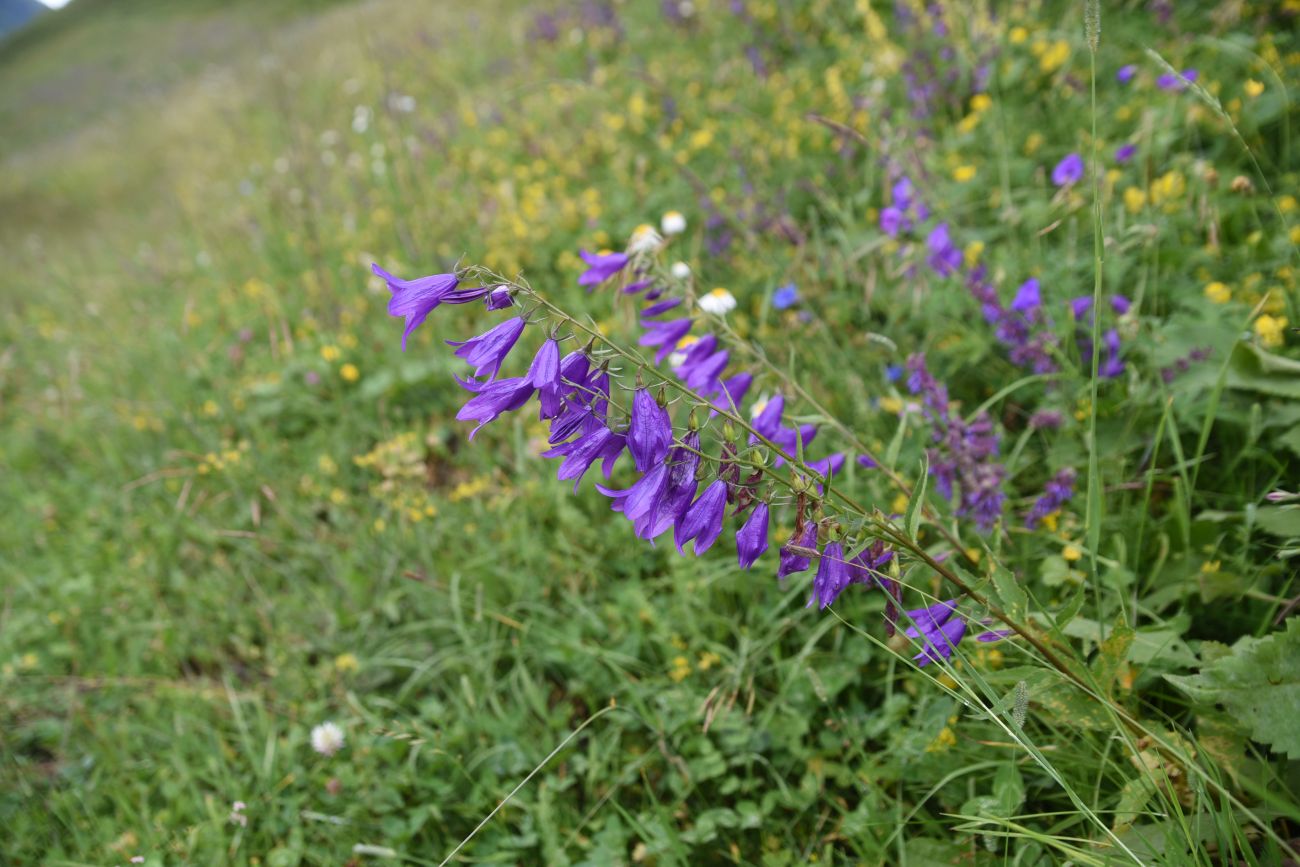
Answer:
[1166,617,1300,759]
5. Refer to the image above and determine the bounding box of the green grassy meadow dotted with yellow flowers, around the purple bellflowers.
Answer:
[0,0,1300,866]
